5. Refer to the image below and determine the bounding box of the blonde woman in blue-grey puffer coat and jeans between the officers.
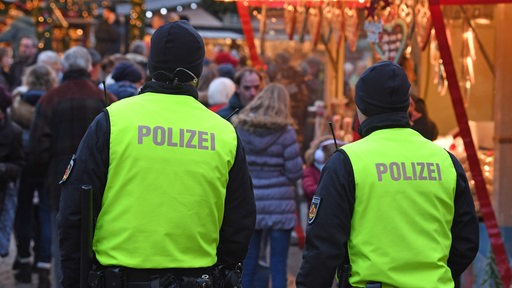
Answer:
[233,83,303,288]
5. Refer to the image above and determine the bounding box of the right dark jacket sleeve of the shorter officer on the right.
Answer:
[448,152,479,279]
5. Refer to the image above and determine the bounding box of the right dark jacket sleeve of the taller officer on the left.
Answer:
[217,136,256,265]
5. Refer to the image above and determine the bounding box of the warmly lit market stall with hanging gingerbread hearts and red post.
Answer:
[233,0,512,287]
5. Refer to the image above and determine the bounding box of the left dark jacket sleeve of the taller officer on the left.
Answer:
[57,112,110,287]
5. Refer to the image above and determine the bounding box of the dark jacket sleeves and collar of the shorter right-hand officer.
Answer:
[296,114,479,288]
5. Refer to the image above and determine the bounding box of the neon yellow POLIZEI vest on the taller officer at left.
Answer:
[93,93,237,268]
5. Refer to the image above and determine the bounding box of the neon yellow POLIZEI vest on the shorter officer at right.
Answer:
[342,128,456,287]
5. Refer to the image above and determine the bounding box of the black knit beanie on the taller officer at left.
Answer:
[148,20,205,83]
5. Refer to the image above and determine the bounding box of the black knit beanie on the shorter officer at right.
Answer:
[355,61,411,117]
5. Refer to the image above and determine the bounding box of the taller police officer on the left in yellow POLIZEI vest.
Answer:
[58,21,256,287]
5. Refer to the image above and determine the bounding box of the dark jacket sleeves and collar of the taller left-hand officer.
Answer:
[57,83,256,287]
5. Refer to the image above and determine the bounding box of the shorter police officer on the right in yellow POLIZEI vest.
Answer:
[296,61,478,288]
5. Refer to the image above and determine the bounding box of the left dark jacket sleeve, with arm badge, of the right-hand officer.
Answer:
[296,150,355,288]
